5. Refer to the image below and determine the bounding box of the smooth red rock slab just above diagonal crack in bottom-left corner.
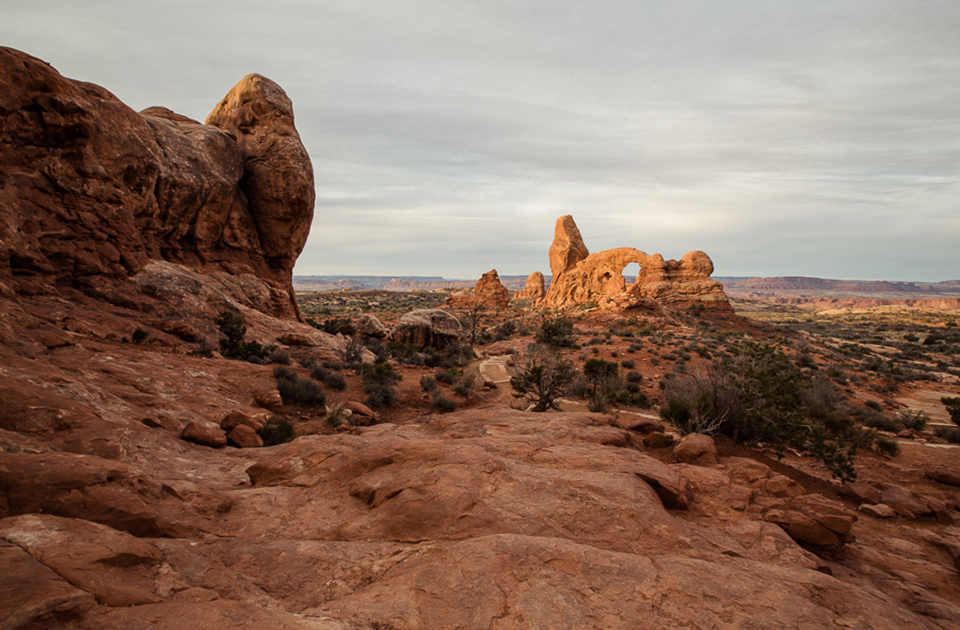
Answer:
[0,514,161,606]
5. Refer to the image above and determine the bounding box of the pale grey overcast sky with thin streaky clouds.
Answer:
[0,0,960,281]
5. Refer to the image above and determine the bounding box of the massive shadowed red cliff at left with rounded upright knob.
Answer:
[0,48,315,317]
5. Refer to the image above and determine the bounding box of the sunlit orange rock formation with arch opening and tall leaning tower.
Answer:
[541,215,732,312]
